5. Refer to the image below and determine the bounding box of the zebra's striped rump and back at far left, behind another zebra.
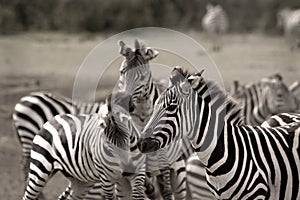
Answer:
[12,91,103,181]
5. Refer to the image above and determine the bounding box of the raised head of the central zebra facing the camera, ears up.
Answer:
[118,40,158,96]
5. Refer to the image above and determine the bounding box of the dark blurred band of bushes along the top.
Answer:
[0,0,299,34]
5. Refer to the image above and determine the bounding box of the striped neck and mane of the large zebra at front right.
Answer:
[190,81,244,165]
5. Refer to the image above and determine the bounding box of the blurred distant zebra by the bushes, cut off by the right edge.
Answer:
[277,8,300,50]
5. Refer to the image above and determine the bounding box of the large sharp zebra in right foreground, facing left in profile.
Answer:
[138,68,300,199]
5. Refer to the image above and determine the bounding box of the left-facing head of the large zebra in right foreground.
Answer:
[138,68,203,153]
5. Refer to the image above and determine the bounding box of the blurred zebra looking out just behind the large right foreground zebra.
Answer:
[230,74,300,125]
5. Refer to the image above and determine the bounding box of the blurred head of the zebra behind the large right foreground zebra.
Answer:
[261,74,298,114]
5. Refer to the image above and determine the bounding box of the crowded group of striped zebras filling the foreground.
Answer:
[13,40,300,200]
